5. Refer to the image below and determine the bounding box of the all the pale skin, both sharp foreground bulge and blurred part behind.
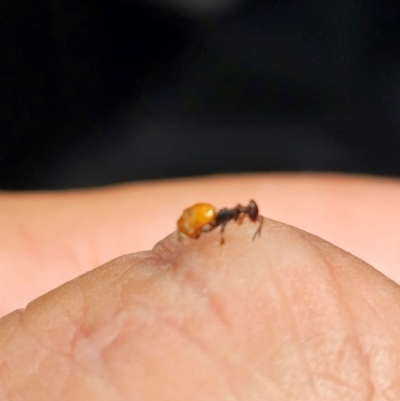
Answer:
[0,175,400,401]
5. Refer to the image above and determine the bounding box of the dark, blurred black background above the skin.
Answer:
[0,0,400,189]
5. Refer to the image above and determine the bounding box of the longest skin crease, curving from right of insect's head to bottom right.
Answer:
[299,230,376,401]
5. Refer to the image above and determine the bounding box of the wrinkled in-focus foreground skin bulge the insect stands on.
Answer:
[0,220,400,401]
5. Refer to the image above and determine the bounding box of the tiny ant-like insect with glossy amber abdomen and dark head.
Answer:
[178,200,263,245]
